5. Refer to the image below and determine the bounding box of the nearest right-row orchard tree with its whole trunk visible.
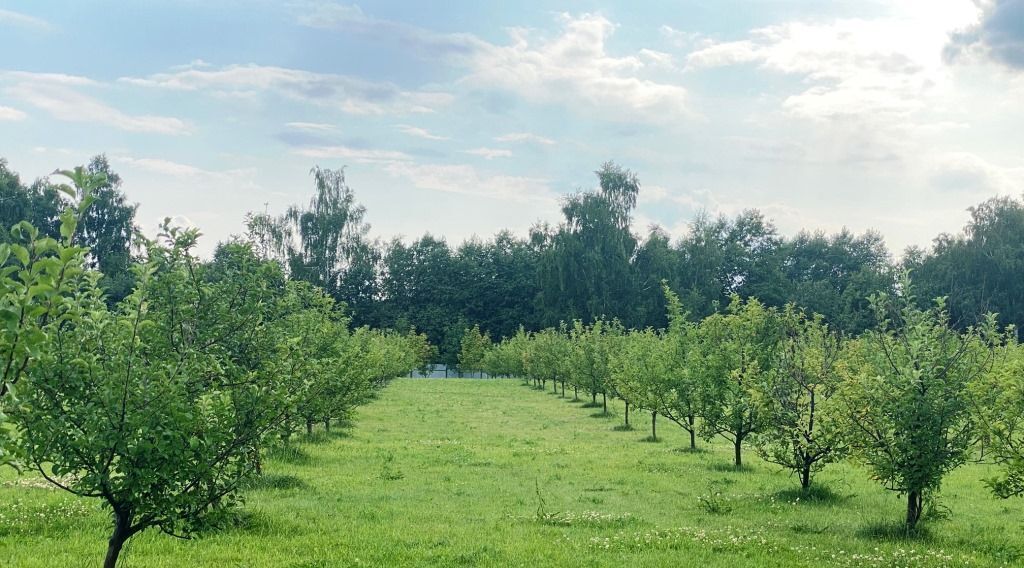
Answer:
[842,278,999,529]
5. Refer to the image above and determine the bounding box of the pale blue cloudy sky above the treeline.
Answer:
[0,0,1024,256]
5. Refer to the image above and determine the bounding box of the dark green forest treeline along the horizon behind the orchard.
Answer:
[0,156,1024,364]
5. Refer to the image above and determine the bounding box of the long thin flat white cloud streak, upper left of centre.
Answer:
[120,64,452,115]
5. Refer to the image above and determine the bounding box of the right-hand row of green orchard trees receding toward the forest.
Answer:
[468,284,1024,530]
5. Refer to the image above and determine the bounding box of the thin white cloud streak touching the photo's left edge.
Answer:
[0,72,190,134]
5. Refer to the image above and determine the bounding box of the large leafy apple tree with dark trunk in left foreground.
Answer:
[10,224,303,568]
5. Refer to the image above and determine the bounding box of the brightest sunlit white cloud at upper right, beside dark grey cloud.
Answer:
[687,0,976,121]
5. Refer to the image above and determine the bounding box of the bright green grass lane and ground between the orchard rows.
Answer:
[0,379,1024,567]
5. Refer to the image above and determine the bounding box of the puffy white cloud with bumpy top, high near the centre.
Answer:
[462,14,691,122]
